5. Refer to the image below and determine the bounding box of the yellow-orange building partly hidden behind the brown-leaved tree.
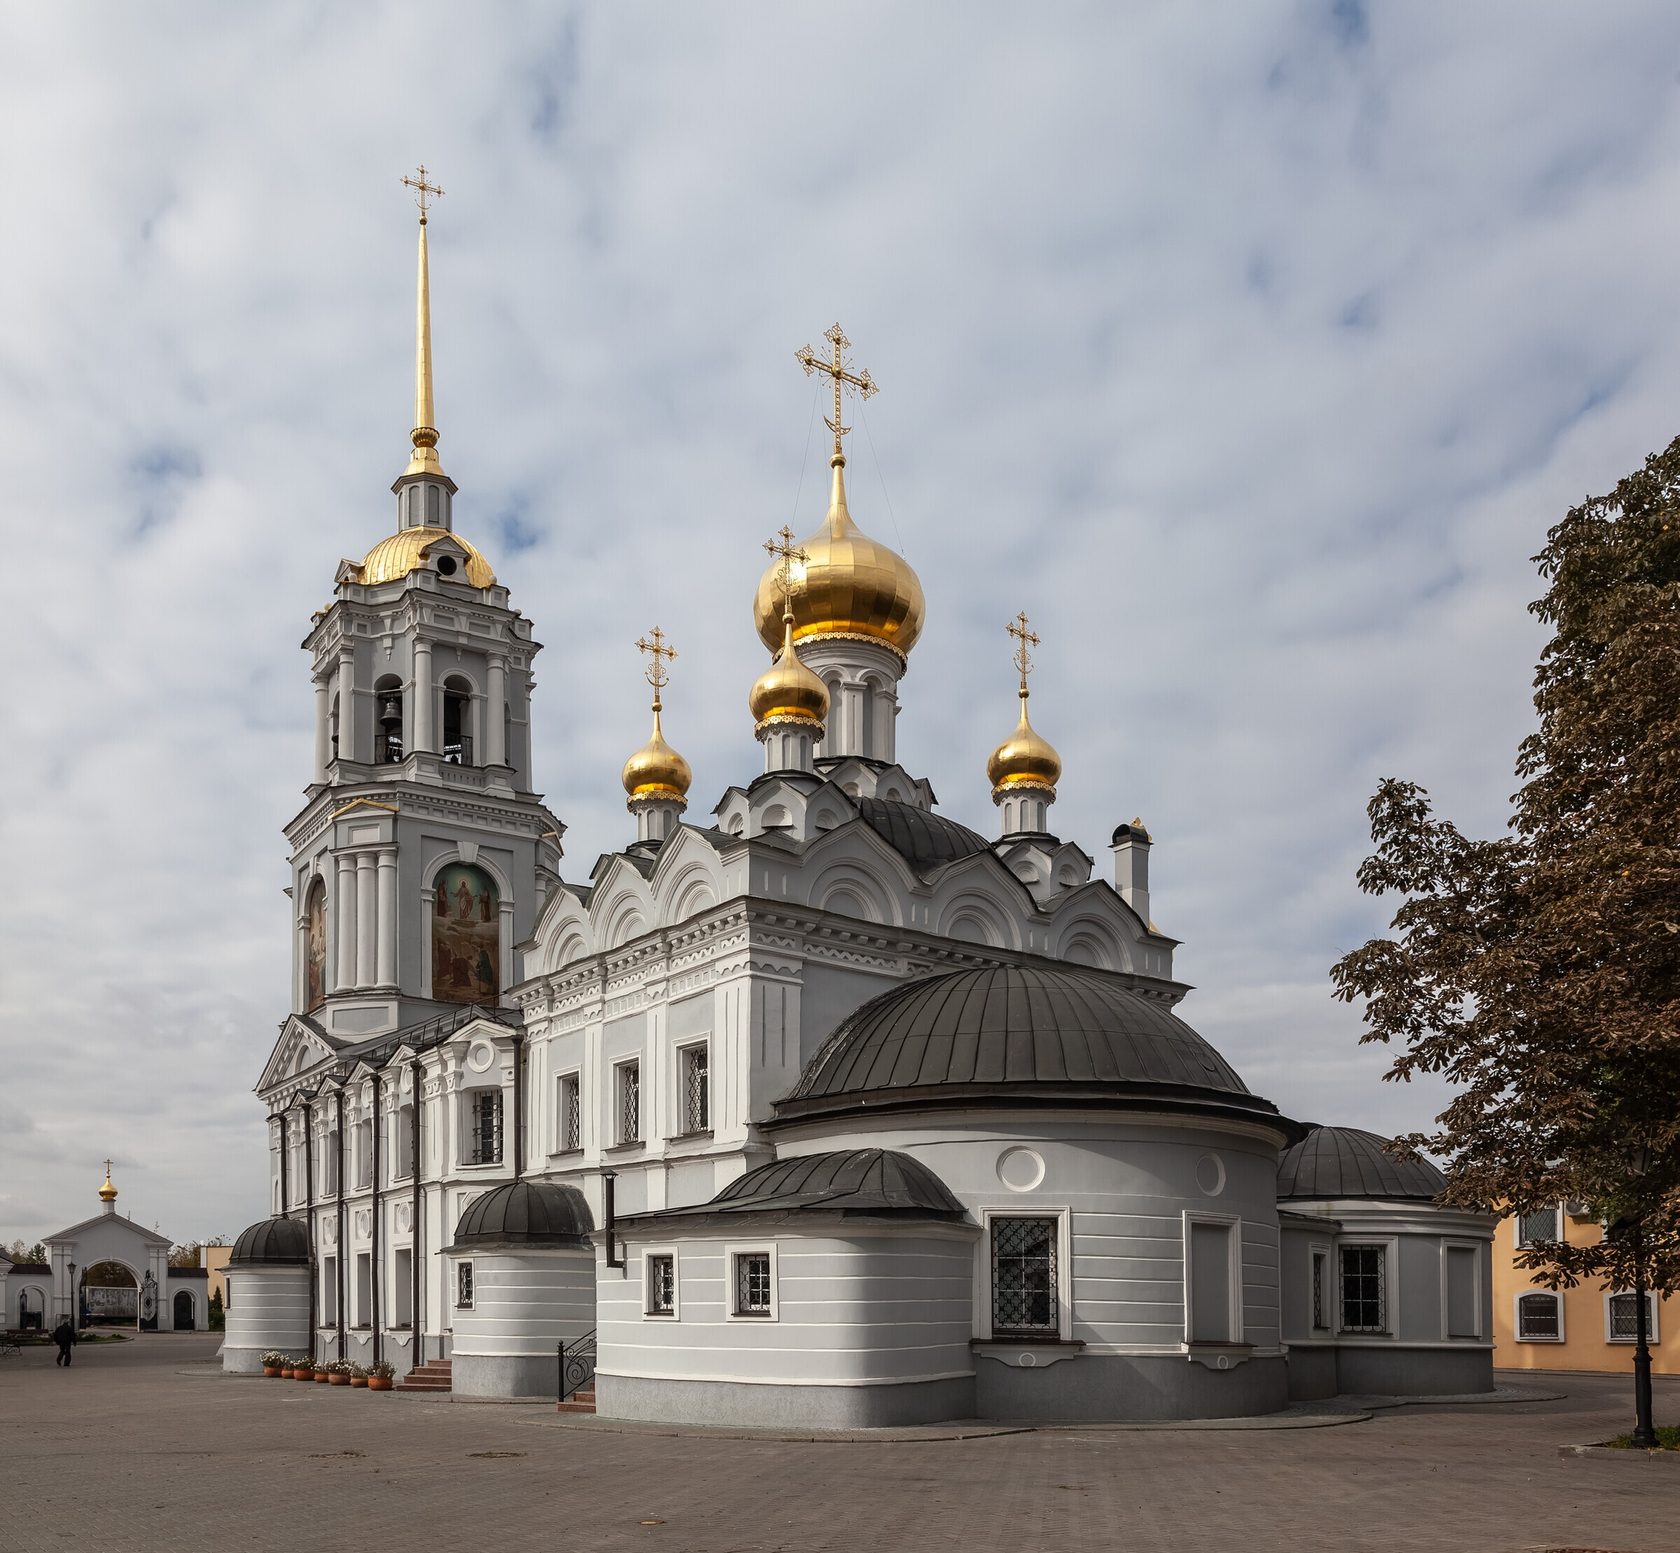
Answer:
[1494,1203,1680,1375]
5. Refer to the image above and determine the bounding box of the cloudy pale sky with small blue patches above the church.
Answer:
[0,0,1680,1240]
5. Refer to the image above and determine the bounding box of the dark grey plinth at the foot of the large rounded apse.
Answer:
[974,1355,1289,1424]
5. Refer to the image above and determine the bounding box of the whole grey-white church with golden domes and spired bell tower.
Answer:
[225,182,1492,1427]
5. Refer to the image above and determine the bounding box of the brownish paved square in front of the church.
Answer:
[0,1335,1680,1553]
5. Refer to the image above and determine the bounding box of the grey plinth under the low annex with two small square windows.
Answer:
[601,1360,974,1429]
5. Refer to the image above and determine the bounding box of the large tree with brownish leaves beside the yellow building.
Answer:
[1332,439,1680,1429]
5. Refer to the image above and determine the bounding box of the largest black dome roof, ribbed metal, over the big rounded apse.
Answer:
[776,965,1280,1121]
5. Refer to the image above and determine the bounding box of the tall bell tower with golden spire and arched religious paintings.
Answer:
[286,166,564,1040]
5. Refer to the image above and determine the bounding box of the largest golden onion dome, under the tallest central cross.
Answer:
[753,454,926,654]
